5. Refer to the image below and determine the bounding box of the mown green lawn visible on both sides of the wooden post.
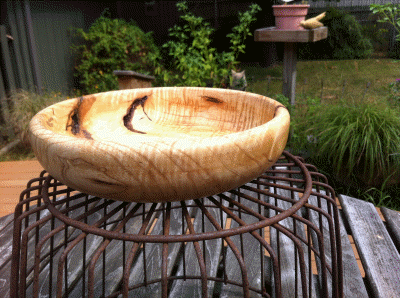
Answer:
[243,59,400,104]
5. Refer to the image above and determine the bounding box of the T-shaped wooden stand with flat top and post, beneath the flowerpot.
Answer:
[254,27,328,105]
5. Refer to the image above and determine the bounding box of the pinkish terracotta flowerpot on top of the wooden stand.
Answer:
[272,0,310,30]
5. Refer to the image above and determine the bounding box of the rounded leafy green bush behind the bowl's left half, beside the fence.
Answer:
[74,16,160,94]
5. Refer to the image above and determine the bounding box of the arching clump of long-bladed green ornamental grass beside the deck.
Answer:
[309,102,400,187]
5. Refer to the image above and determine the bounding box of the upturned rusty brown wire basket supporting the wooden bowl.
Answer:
[11,152,343,297]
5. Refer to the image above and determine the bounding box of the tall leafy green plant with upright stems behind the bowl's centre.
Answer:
[159,2,261,87]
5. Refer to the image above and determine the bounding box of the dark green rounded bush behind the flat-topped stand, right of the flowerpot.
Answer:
[299,7,373,59]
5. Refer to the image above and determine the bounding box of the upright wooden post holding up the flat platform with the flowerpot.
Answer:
[282,42,297,106]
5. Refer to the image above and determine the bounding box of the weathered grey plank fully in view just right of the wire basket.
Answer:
[339,195,400,298]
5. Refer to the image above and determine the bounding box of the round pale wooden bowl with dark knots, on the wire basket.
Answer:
[29,87,290,202]
